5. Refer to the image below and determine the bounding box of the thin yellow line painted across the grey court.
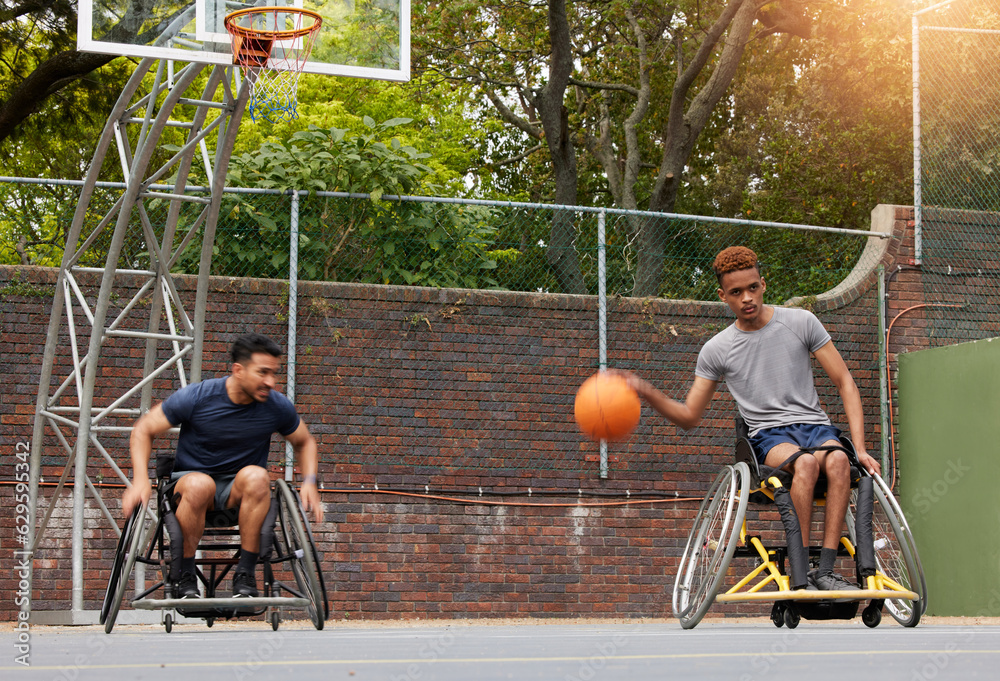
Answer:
[0,648,1000,671]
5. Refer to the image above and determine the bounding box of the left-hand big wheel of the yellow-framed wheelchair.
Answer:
[673,462,750,629]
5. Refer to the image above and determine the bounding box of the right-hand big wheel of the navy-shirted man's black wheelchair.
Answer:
[272,480,328,629]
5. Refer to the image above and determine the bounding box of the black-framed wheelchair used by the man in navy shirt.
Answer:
[100,455,329,634]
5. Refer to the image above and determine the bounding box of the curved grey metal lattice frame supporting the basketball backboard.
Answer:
[28,58,249,624]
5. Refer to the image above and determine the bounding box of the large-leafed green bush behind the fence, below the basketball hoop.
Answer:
[181,117,496,288]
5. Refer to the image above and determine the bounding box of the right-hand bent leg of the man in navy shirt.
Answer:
[226,466,271,596]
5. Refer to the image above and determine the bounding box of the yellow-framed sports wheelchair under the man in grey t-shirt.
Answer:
[672,418,927,629]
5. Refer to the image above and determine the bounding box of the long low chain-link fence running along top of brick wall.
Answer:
[0,178,868,304]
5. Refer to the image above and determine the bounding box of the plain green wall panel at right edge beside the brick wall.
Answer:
[897,339,1000,616]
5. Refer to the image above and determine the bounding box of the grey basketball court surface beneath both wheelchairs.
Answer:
[0,619,1000,681]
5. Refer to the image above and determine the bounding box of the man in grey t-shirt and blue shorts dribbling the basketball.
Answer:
[623,246,880,590]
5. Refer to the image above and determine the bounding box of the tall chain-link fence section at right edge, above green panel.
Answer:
[913,0,1000,345]
